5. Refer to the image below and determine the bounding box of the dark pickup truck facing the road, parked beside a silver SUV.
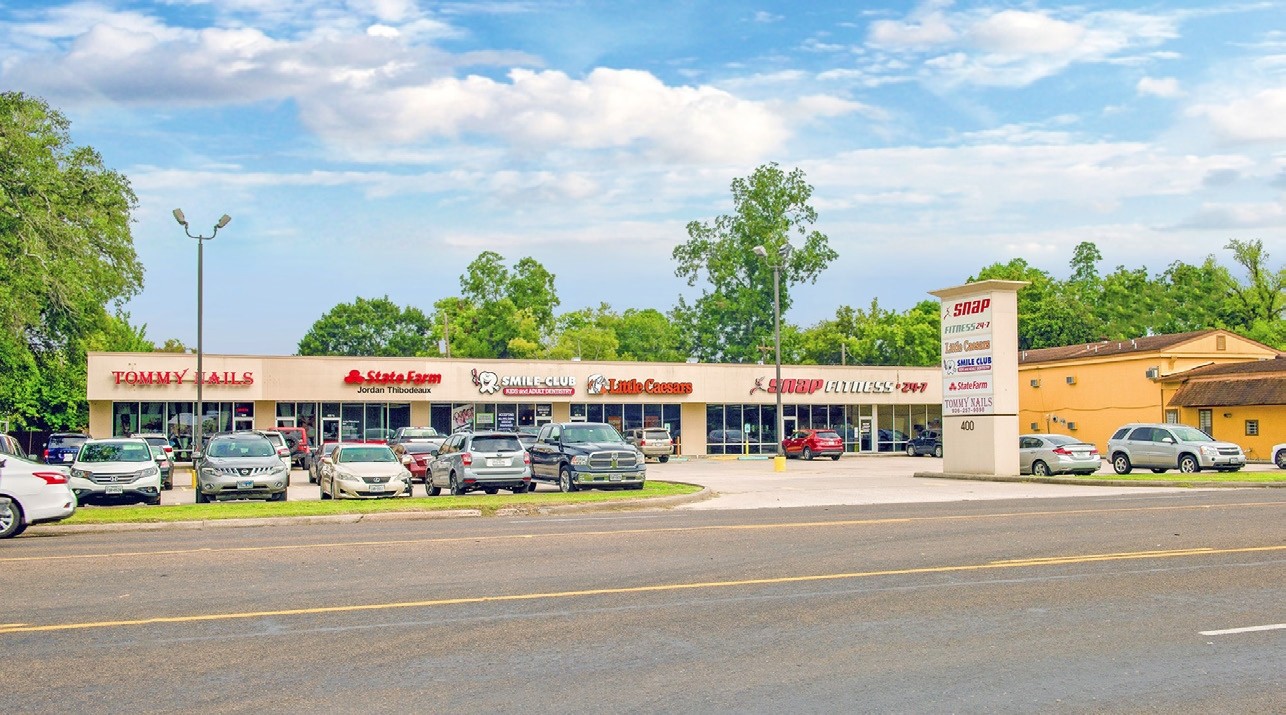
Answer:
[527,422,647,491]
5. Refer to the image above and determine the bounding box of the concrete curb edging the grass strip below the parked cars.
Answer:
[27,482,715,535]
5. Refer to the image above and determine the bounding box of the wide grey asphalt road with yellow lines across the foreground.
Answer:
[0,490,1286,712]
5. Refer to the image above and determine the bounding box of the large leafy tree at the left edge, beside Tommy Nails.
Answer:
[0,93,143,430]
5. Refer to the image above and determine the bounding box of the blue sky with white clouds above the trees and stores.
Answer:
[0,0,1286,355]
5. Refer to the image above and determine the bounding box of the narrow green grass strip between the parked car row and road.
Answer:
[60,481,701,523]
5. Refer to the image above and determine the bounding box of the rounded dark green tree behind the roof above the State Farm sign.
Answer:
[298,296,437,358]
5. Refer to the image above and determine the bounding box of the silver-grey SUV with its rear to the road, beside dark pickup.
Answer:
[424,432,531,496]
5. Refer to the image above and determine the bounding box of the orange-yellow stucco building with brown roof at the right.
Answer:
[1019,330,1286,459]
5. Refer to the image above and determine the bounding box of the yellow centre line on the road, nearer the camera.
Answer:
[0,545,1286,635]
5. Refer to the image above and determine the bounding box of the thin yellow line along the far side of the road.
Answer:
[0,502,1286,563]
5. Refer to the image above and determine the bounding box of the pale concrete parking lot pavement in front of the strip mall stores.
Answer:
[120,455,1276,509]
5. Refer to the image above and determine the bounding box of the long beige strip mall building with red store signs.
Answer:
[87,352,941,455]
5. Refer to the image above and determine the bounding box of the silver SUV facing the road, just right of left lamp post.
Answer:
[194,431,291,504]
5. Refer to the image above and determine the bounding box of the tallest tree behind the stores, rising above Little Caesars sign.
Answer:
[673,163,838,361]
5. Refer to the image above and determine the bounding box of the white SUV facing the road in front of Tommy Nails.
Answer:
[71,437,161,505]
